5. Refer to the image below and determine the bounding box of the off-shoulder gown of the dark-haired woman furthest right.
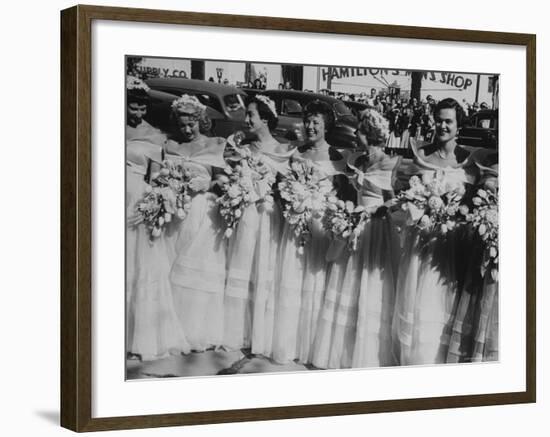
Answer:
[393,142,474,365]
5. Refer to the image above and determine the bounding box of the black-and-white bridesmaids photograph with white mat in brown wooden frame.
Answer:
[61,6,536,432]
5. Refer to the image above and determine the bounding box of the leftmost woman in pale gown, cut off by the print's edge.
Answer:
[126,77,189,360]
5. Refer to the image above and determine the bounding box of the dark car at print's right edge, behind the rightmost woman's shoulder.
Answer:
[458,109,498,149]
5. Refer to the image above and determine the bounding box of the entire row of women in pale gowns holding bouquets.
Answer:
[126,77,498,369]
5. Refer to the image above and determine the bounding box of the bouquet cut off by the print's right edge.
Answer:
[460,189,498,281]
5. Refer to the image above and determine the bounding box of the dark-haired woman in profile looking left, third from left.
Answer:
[223,95,293,356]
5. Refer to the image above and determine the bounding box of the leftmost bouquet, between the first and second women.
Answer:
[134,161,191,240]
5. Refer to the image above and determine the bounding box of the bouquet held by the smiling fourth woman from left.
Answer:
[278,159,332,252]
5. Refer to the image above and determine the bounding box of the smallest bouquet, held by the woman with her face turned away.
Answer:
[323,196,370,251]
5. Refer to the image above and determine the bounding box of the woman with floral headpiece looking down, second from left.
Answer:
[165,94,230,351]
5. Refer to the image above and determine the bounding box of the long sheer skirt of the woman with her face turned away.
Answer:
[313,217,399,369]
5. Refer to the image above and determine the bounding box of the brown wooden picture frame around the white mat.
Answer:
[61,6,536,432]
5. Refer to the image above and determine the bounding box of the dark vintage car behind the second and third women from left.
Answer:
[146,77,250,138]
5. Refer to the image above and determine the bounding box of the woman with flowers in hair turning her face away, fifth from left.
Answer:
[313,109,400,369]
